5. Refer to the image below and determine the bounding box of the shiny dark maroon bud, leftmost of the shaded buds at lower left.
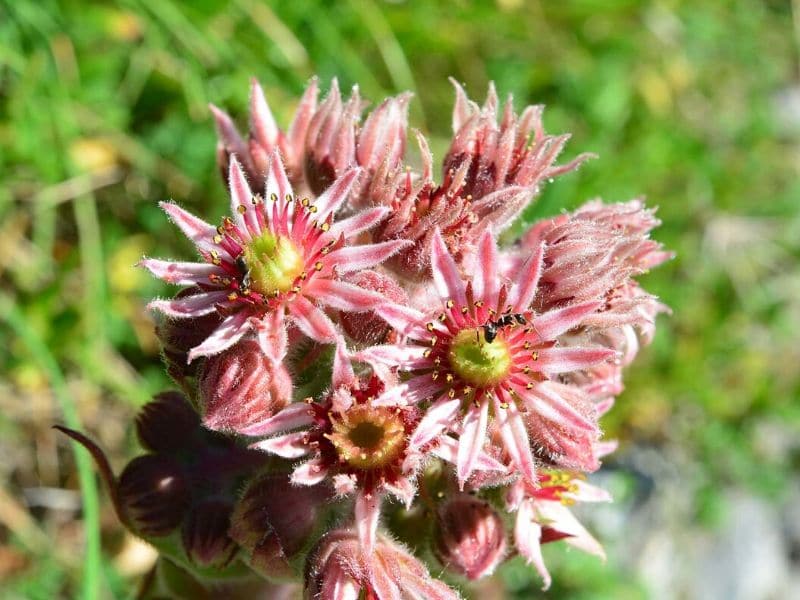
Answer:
[118,454,190,538]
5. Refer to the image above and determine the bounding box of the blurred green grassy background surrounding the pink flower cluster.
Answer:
[0,0,800,598]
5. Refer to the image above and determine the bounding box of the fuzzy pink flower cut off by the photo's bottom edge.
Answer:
[305,529,460,600]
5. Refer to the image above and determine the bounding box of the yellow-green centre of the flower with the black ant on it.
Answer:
[447,327,511,387]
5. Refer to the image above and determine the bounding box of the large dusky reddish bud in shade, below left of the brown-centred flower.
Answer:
[229,473,330,577]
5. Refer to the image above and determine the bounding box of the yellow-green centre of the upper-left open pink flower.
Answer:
[244,232,303,295]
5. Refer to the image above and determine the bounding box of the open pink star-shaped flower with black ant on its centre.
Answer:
[356,231,614,487]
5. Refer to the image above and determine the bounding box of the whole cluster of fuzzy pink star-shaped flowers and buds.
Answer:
[61,80,670,599]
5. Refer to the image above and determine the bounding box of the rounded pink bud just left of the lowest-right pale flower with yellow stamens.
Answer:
[433,495,506,580]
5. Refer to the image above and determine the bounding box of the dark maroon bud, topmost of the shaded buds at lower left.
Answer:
[136,392,200,454]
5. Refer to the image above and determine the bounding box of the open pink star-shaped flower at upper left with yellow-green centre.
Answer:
[141,153,406,361]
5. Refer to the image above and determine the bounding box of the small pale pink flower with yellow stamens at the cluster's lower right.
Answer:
[507,471,611,590]
